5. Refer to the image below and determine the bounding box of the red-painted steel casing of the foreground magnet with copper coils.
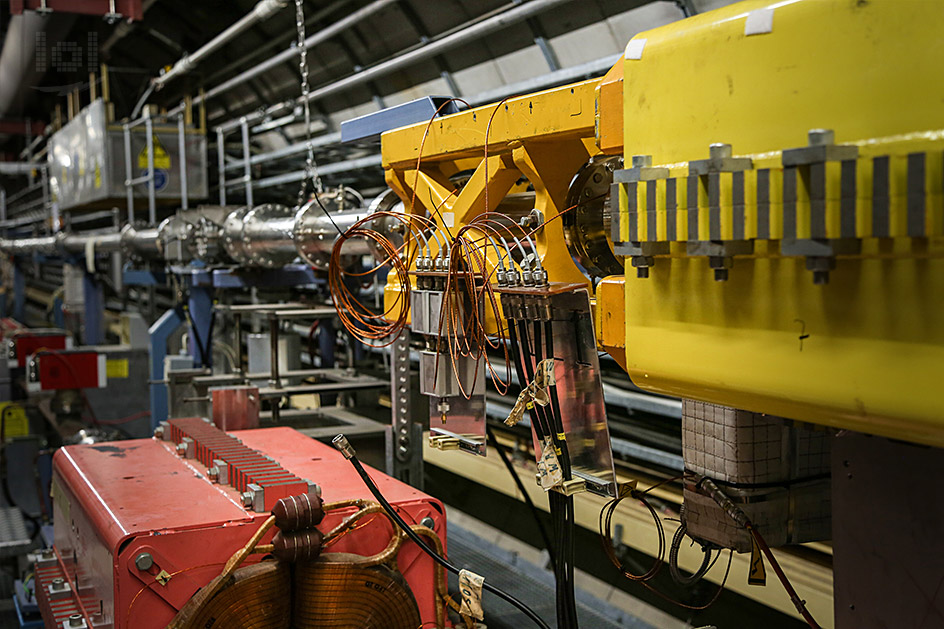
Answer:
[36,420,446,629]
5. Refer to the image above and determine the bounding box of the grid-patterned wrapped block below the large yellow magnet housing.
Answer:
[682,400,831,552]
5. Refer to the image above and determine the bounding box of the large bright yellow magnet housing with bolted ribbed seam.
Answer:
[616,0,944,446]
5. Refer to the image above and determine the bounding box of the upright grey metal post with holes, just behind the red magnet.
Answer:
[386,330,423,489]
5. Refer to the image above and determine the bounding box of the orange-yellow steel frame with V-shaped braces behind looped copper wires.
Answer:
[382,80,599,332]
